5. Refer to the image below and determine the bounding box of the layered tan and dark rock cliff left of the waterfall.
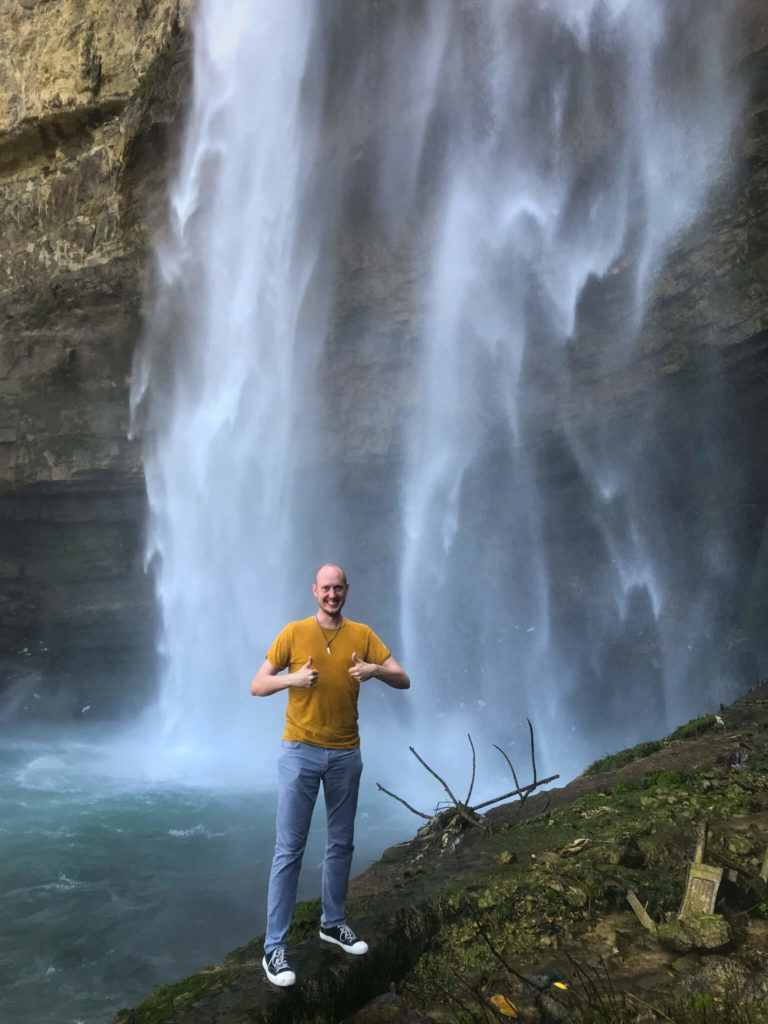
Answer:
[0,0,190,712]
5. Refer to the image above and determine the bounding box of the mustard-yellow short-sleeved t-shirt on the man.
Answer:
[266,615,389,750]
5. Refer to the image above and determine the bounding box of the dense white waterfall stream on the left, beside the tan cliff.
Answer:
[133,0,342,782]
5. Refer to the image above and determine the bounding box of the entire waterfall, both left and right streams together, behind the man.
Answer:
[133,0,736,782]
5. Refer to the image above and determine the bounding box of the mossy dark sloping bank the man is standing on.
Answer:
[113,685,768,1024]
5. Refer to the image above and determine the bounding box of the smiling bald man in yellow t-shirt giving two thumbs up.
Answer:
[251,565,411,986]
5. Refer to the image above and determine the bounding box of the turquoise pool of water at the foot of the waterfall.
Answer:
[0,733,414,1024]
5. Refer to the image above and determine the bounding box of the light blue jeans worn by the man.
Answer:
[264,739,362,954]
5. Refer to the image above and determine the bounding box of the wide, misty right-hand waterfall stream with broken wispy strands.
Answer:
[393,0,733,770]
